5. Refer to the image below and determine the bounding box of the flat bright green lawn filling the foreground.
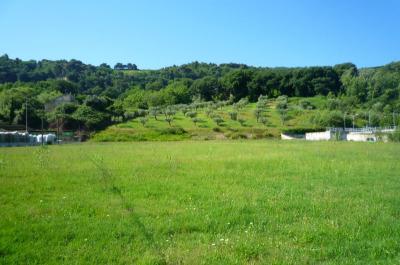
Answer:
[0,140,400,264]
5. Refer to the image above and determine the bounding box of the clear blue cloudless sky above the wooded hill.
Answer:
[0,0,400,69]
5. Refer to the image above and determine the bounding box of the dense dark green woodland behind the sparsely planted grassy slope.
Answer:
[0,55,400,131]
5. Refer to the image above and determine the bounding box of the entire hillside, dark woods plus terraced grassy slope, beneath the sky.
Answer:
[0,55,400,136]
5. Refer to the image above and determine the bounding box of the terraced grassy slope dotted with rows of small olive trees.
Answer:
[93,97,367,142]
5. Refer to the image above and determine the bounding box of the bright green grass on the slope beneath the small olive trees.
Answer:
[92,97,325,142]
